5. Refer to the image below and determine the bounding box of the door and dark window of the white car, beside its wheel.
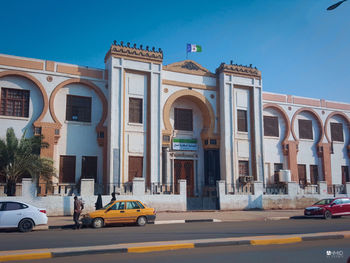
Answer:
[1,202,26,227]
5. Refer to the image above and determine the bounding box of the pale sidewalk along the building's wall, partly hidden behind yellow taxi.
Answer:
[48,210,304,227]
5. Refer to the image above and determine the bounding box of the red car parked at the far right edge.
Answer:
[304,197,350,219]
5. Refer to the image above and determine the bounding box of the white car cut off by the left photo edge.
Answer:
[0,201,47,232]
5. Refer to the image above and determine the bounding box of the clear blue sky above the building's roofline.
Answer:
[0,0,350,103]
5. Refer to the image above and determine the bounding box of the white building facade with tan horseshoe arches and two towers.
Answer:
[0,42,350,202]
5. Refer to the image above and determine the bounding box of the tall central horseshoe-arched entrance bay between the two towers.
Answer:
[162,90,220,210]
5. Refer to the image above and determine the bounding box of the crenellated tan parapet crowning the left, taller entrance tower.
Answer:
[105,40,163,63]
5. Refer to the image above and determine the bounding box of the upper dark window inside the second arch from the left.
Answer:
[66,95,91,122]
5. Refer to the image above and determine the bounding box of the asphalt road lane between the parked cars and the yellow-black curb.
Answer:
[0,217,350,251]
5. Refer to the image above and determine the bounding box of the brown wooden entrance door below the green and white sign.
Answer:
[174,160,194,197]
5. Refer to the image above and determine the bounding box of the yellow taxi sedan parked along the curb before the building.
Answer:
[82,200,156,228]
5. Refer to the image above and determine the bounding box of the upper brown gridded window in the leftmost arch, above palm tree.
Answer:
[0,88,29,117]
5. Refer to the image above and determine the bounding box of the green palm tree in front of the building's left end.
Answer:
[0,128,56,196]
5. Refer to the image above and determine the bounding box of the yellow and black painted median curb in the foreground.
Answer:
[0,231,350,262]
